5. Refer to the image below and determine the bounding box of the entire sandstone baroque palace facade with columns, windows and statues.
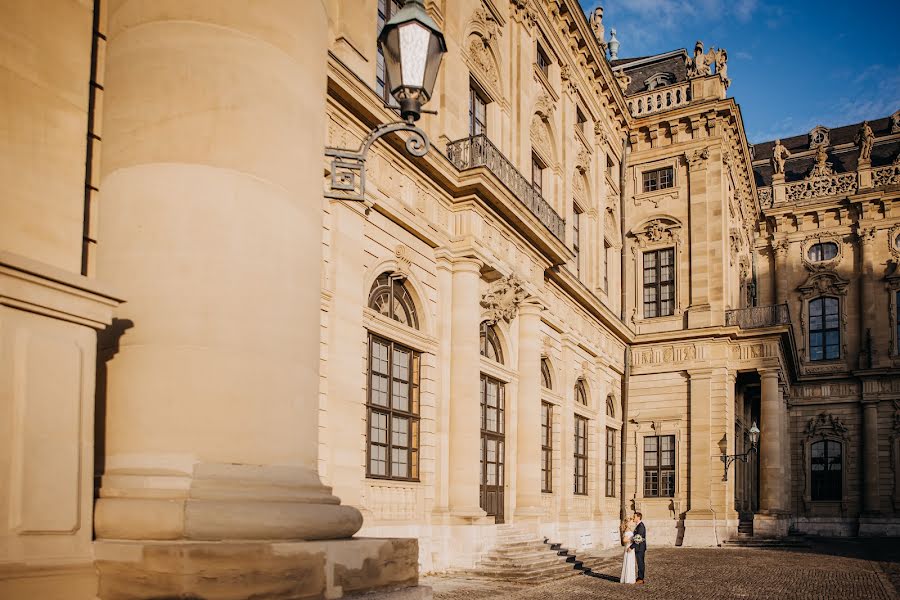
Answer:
[0,0,900,599]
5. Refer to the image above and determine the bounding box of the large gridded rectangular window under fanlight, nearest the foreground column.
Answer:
[366,334,420,480]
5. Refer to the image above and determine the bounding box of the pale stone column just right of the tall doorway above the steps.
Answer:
[516,302,541,518]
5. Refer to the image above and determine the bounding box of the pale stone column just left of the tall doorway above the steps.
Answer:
[450,258,486,517]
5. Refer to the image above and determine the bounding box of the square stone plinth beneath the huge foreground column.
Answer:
[94,538,431,600]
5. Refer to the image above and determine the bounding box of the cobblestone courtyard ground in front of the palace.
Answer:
[422,539,900,600]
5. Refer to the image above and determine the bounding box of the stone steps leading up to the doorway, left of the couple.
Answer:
[466,525,610,583]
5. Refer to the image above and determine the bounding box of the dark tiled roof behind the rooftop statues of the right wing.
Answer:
[753,117,900,187]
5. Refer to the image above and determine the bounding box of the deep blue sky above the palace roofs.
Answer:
[581,0,900,142]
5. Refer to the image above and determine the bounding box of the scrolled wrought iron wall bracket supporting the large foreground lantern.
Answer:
[325,119,431,202]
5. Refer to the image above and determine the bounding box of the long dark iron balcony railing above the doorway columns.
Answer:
[447,134,566,241]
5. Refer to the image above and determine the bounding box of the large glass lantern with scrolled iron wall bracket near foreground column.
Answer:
[325,0,447,202]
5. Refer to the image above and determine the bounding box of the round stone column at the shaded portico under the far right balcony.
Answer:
[754,369,787,537]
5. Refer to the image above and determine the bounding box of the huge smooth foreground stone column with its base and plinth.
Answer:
[89,0,417,599]
